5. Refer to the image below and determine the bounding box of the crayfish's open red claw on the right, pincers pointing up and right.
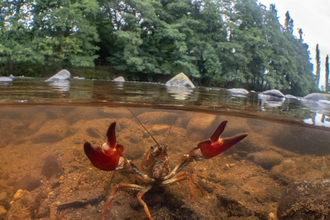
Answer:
[198,121,247,159]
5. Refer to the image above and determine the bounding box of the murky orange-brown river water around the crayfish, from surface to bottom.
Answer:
[0,79,330,219]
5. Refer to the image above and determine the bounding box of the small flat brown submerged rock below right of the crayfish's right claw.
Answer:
[247,151,283,170]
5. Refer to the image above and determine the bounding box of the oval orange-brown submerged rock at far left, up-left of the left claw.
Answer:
[31,119,68,143]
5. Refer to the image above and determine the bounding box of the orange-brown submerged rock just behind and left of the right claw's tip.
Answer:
[187,113,218,141]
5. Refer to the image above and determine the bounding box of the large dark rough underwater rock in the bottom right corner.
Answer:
[277,179,330,220]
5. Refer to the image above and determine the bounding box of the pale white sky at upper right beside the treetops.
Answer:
[258,0,330,87]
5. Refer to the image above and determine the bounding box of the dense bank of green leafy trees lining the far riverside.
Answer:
[0,0,319,96]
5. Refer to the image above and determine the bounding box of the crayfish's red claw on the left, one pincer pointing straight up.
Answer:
[84,122,124,171]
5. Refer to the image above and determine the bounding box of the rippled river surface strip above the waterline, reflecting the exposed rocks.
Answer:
[0,78,330,127]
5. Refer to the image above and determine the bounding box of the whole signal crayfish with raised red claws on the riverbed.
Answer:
[84,114,247,220]
